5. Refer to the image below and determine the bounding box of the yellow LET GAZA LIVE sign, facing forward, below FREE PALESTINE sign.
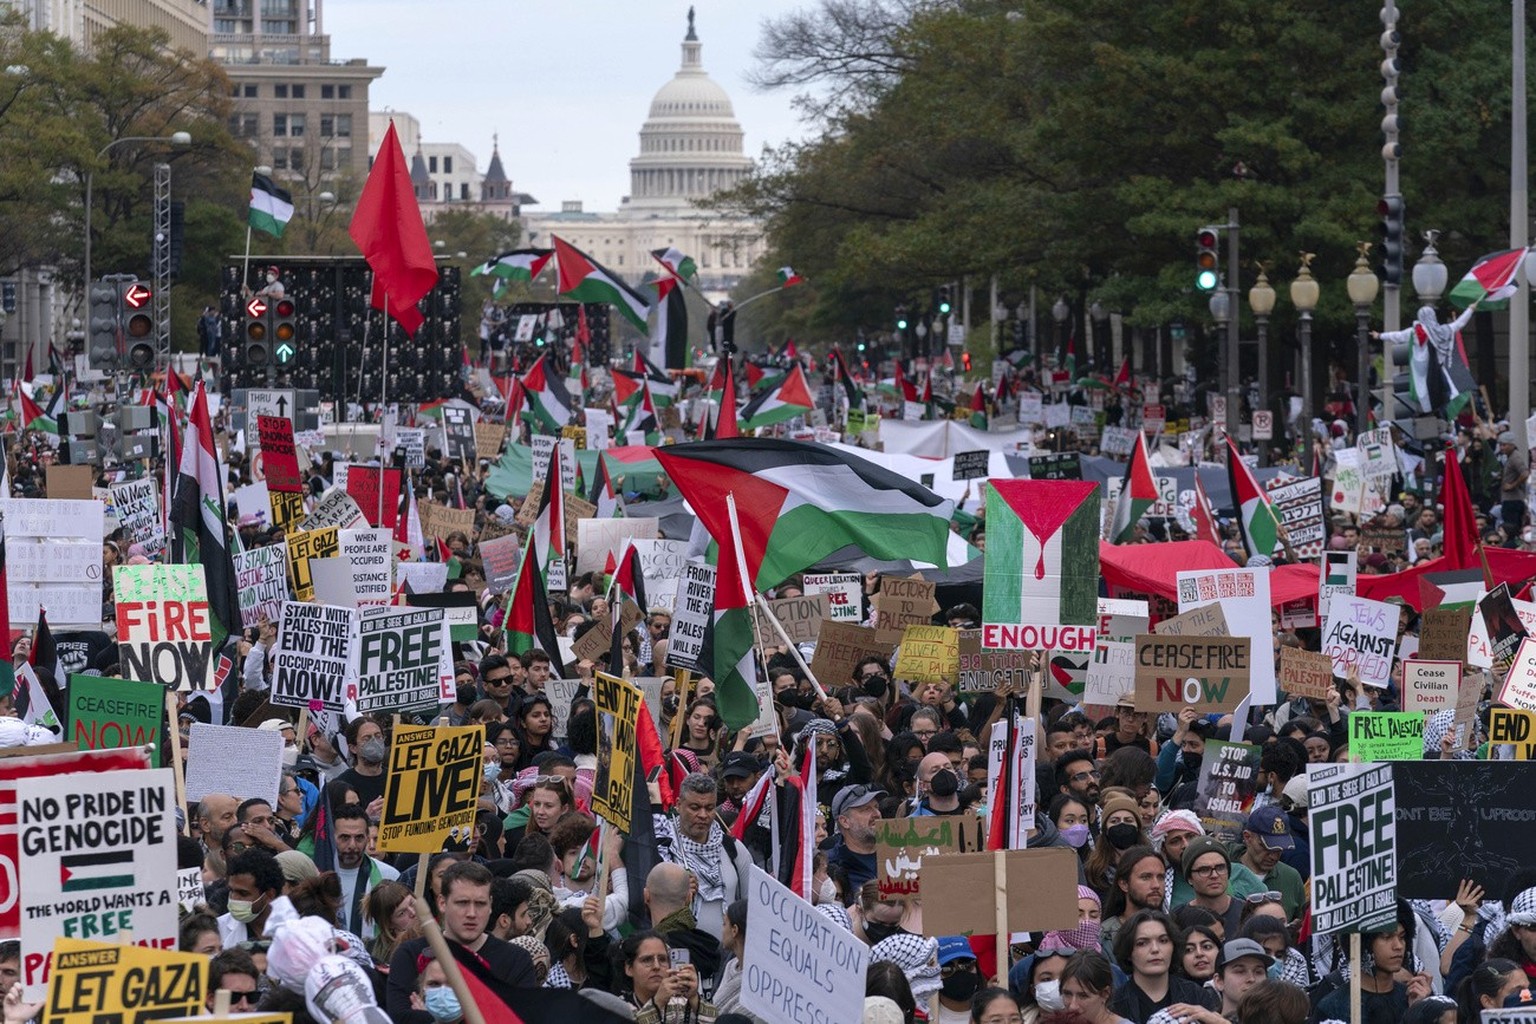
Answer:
[379,725,485,854]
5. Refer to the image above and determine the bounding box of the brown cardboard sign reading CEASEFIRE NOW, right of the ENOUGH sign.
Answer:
[1135,623,1252,714]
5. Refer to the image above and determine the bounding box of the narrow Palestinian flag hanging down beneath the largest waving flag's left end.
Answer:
[715,494,774,729]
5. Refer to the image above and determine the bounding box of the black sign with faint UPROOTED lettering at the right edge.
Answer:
[1400,760,1536,900]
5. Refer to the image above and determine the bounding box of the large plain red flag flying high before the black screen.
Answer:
[347,121,438,336]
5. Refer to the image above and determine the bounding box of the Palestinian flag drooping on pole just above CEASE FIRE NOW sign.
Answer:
[170,384,240,651]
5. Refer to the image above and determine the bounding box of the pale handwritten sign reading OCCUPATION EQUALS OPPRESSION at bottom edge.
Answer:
[742,858,878,1022]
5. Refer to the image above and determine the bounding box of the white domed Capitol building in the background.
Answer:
[521,9,763,301]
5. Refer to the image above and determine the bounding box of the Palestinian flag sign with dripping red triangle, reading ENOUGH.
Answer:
[982,481,1100,651]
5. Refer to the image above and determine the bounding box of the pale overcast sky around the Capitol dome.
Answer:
[321,0,811,210]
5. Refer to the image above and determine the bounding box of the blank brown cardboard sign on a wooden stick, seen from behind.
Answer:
[921,846,1077,939]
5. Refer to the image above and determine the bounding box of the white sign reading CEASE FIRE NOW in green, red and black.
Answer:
[112,565,214,689]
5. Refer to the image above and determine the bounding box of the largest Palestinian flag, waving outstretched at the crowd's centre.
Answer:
[654,438,954,590]
